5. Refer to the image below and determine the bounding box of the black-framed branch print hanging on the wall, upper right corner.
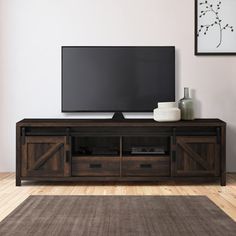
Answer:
[195,0,236,55]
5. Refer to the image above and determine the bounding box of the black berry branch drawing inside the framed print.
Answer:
[197,1,234,48]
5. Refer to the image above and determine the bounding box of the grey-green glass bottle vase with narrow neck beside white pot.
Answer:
[179,88,194,120]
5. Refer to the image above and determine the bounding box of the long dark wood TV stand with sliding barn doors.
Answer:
[16,119,226,186]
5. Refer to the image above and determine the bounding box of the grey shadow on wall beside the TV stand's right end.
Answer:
[226,124,236,172]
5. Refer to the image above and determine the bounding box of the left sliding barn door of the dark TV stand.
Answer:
[21,136,70,177]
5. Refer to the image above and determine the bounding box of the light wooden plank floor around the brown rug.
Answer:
[0,173,236,221]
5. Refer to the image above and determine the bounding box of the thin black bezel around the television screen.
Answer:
[61,46,176,113]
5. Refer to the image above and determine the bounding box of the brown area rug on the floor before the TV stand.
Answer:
[0,196,236,236]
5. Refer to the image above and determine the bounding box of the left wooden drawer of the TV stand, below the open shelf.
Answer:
[72,156,120,176]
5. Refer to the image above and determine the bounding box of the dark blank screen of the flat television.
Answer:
[62,46,175,112]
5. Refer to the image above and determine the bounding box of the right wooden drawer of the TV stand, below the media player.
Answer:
[122,156,170,176]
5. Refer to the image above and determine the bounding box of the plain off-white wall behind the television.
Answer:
[0,0,236,171]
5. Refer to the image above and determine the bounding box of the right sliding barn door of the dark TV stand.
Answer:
[172,136,220,176]
